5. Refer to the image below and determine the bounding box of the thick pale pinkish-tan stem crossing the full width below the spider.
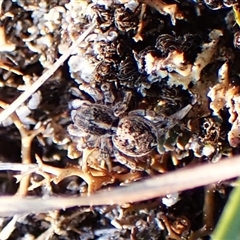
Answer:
[0,156,240,216]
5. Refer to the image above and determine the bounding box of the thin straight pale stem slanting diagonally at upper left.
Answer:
[0,24,96,122]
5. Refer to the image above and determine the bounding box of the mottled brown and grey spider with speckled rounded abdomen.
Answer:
[68,85,192,171]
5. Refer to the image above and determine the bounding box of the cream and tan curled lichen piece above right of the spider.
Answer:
[141,29,222,89]
